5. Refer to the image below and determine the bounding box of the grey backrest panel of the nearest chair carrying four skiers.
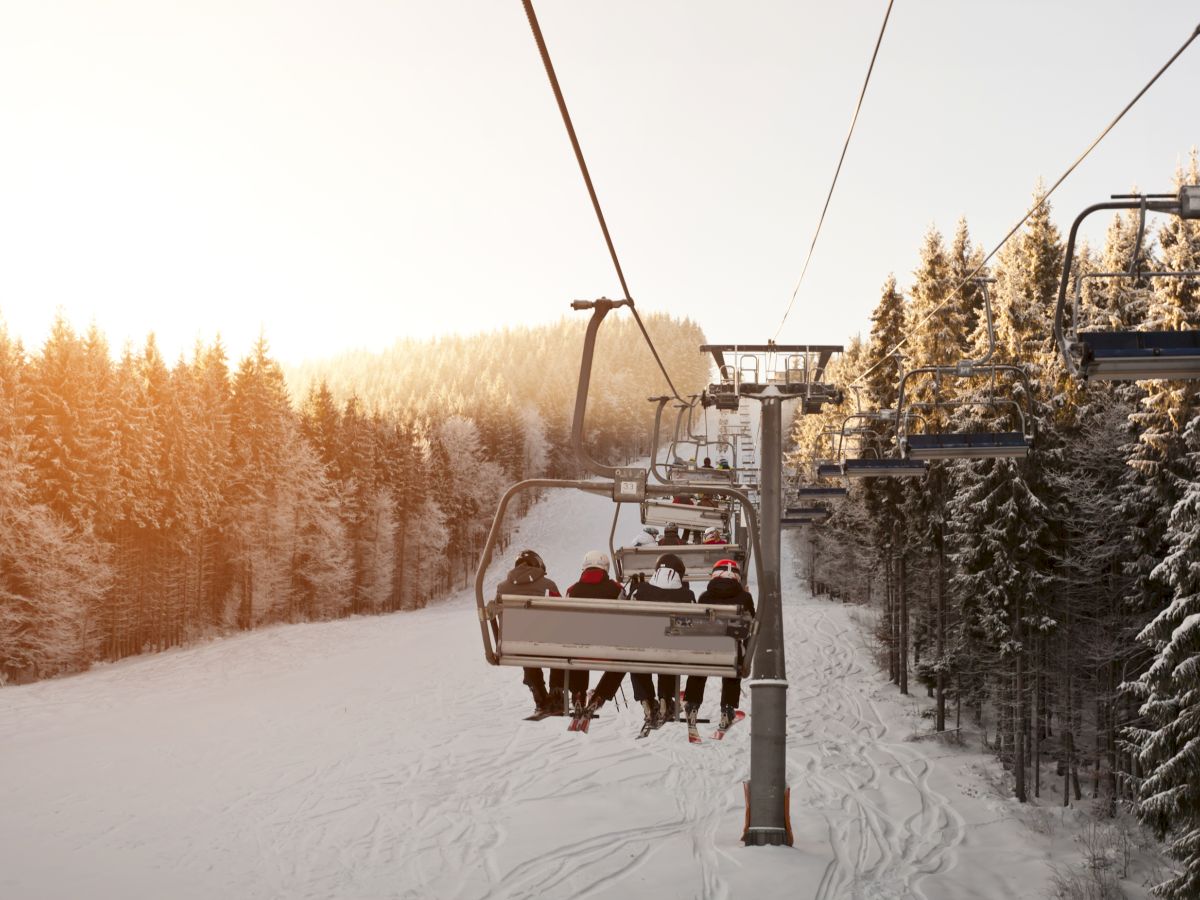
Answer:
[487,595,752,678]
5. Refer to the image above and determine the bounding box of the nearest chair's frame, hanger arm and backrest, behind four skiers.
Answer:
[475,299,764,677]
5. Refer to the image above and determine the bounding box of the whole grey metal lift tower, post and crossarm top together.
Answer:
[700,341,842,846]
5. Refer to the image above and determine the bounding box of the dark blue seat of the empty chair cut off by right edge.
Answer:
[1076,331,1200,382]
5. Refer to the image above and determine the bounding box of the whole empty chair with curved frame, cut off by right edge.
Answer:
[1054,185,1200,382]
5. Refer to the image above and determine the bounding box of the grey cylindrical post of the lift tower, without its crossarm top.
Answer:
[742,386,788,846]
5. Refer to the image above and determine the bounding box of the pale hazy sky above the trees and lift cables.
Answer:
[0,0,1200,361]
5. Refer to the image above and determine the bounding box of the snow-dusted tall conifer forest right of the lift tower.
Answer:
[792,158,1200,900]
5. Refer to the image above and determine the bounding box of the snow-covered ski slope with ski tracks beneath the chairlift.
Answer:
[0,492,1089,900]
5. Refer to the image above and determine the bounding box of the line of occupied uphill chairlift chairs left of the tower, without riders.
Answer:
[475,300,763,677]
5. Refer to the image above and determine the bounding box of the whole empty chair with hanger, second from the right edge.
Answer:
[896,278,1033,461]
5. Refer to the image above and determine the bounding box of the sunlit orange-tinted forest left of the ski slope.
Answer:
[0,316,707,684]
